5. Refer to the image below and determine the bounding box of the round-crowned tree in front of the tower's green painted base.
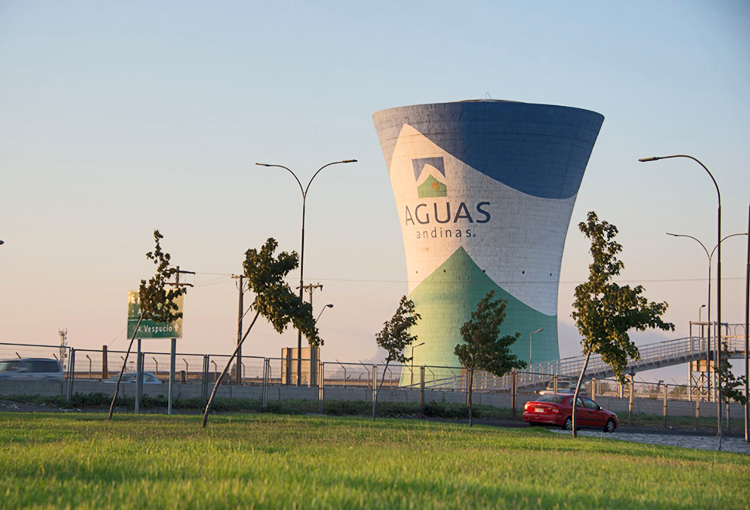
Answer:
[454,290,526,426]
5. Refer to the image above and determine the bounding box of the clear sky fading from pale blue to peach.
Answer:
[0,0,750,380]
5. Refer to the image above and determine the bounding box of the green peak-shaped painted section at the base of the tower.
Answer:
[402,247,560,384]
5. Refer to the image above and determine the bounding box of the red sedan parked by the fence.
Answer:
[523,395,620,432]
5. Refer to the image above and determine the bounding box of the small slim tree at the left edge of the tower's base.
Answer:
[372,296,422,421]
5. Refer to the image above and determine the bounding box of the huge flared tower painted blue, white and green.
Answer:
[373,100,604,374]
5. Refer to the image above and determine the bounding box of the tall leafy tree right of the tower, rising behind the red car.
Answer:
[571,211,674,437]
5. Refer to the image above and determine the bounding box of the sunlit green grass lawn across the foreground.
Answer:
[0,413,750,509]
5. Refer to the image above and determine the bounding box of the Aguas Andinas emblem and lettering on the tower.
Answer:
[404,157,491,239]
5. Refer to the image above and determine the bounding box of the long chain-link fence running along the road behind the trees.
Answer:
[0,343,741,424]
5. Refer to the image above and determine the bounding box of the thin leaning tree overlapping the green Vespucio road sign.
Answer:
[107,230,187,420]
